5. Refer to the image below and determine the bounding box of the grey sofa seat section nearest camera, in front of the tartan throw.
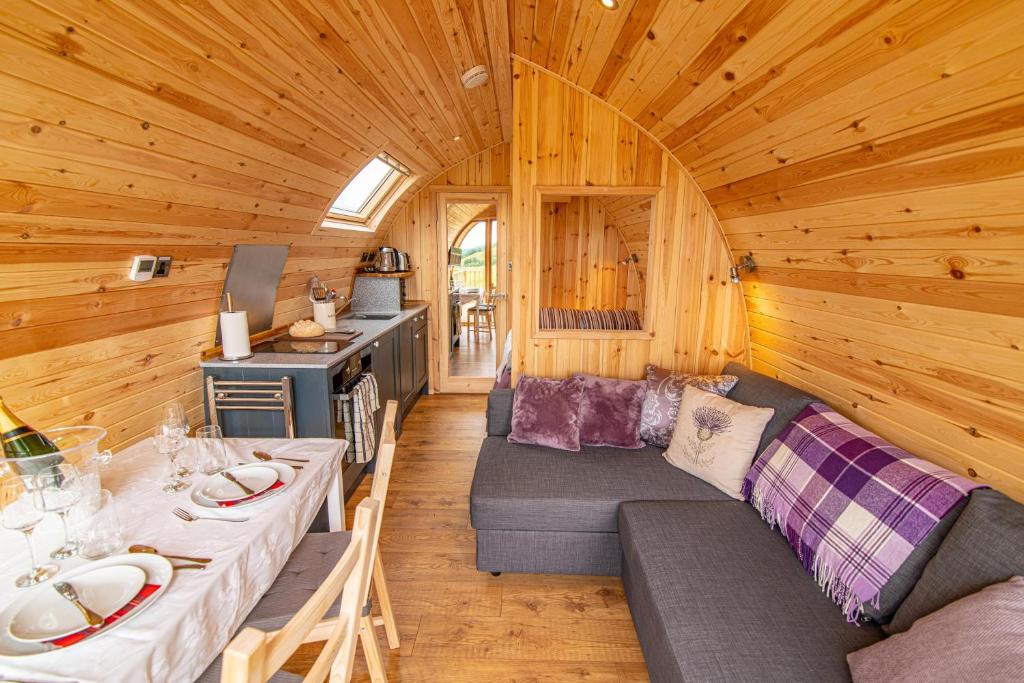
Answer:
[618,502,882,683]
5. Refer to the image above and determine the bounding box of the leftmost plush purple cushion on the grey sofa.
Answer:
[508,377,583,451]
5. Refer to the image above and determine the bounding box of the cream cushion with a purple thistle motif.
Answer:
[665,386,775,501]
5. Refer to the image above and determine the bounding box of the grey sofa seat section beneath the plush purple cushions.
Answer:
[470,436,733,532]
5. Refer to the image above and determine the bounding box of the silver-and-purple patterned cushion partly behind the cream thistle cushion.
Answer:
[640,365,739,449]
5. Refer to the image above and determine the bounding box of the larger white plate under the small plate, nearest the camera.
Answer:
[0,553,172,657]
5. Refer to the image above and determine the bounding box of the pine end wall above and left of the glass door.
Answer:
[384,143,510,387]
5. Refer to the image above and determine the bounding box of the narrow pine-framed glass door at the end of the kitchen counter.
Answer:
[435,191,509,393]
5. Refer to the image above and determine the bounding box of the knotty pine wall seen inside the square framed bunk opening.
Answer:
[538,196,650,317]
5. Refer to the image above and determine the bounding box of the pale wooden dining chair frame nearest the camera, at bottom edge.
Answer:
[220,498,383,683]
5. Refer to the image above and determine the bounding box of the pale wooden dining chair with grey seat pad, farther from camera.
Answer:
[199,400,400,683]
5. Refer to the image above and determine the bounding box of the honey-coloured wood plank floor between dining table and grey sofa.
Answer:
[288,395,647,683]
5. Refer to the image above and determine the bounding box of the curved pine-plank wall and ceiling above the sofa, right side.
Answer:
[511,0,1024,500]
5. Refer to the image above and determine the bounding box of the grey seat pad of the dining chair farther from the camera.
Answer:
[196,531,352,683]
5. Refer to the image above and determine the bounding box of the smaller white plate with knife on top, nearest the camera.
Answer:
[7,564,145,643]
